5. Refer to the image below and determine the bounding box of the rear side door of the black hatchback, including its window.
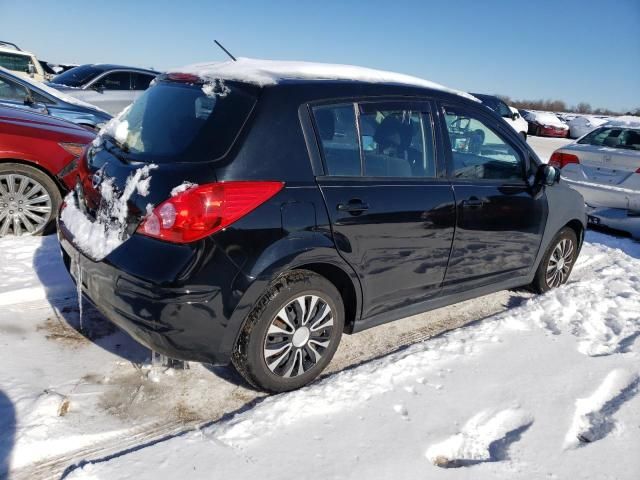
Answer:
[312,101,455,317]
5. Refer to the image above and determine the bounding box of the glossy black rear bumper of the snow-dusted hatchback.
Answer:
[58,221,249,365]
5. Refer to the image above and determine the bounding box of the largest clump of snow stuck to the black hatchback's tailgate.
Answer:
[60,164,157,260]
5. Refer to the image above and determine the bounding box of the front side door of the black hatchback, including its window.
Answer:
[440,101,547,291]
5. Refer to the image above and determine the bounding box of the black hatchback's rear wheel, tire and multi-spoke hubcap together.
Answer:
[232,270,344,393]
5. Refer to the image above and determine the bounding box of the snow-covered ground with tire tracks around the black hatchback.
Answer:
[0,137,640,480]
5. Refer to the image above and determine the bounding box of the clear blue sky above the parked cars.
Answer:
[0,0,640,110]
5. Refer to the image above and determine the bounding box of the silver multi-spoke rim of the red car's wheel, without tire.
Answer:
[0,173,51,237]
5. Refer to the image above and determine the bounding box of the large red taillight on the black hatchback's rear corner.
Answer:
[137,182,284,243]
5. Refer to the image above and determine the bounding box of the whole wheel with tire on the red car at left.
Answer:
[0,163,62,238]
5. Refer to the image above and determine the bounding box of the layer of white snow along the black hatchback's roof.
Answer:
[170,57,479,101]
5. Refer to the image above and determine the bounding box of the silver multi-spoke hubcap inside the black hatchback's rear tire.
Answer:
[263,294,333,378]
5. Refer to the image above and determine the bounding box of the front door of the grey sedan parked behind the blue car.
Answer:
[82,70,134,115]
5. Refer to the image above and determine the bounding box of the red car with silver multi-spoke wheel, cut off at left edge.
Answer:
[0,106,95,237]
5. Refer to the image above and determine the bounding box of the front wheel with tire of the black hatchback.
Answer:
[531,227,578,293]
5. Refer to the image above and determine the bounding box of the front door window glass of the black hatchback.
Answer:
[445,108,523,180]
